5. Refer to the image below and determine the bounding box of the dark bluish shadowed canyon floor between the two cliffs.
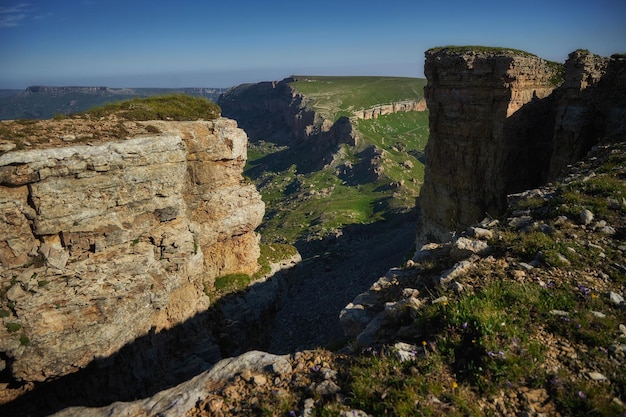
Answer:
[269,212,417,354]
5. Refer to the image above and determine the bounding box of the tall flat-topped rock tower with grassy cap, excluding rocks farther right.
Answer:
[420,47,559,239]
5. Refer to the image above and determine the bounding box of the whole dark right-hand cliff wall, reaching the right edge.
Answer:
[419,47,624,240]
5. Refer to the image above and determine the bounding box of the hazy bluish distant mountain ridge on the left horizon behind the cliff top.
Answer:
[0,85,227,120]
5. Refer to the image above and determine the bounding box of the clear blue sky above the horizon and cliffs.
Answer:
[0,0,626,88]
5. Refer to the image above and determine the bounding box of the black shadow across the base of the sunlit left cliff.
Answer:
[0,266,297,417]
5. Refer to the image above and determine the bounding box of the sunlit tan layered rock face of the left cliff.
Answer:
[0,118,264,381]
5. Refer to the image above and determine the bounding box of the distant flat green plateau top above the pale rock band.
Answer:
[291,75,426,121]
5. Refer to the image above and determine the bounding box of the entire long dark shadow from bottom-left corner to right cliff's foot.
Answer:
[0,211,417,417]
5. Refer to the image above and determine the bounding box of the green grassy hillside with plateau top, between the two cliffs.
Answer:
[246,77,428,243]
